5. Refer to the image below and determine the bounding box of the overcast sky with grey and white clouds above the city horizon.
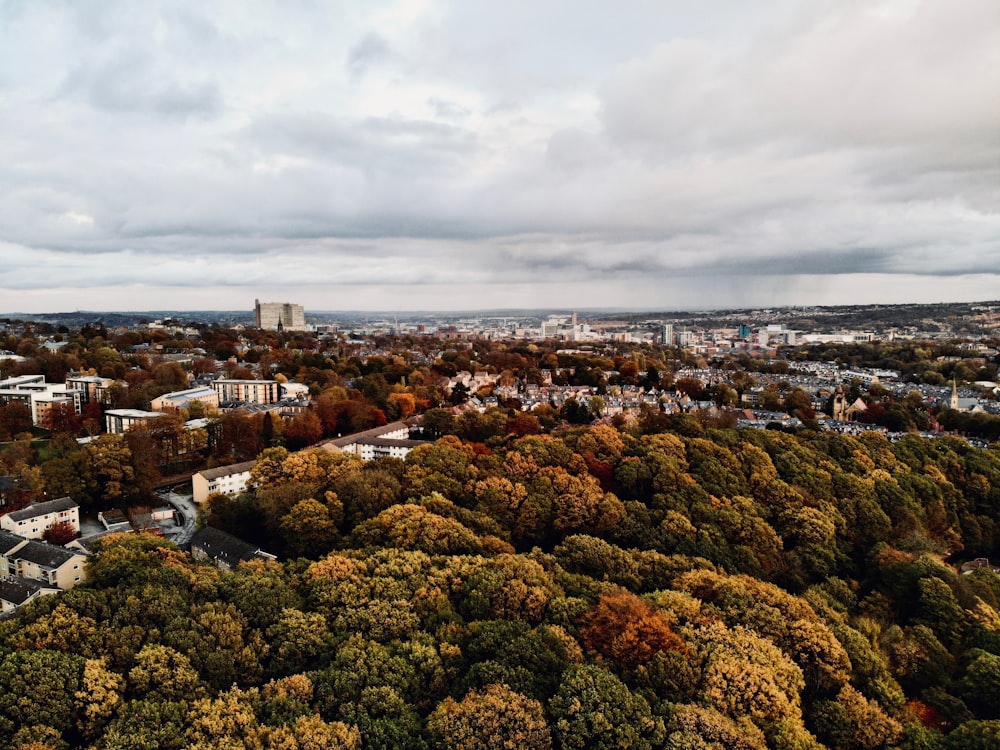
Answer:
[0,0,1000,314]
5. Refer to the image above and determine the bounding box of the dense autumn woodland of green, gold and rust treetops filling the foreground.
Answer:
[0,426,1000,750]
